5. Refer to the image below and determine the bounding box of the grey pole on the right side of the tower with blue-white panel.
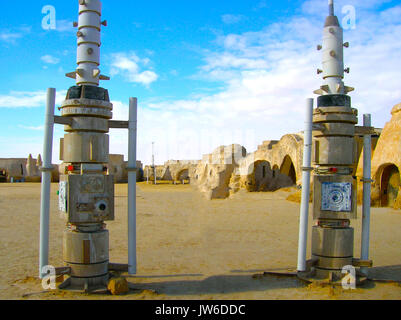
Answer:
[361,114,372,273]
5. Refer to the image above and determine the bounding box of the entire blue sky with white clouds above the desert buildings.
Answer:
[0,0,401,163]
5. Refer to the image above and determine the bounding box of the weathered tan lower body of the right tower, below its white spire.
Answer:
[312,94,358,279]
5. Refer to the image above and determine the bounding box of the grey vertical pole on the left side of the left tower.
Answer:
[39,88,56,279]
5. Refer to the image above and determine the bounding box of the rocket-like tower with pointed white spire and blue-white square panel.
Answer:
[298,0,371,282]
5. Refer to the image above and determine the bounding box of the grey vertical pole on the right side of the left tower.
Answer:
[128,98,138,274]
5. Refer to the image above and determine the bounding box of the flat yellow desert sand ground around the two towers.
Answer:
[0,183,401,300]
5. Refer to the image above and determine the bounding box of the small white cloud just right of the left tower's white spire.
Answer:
[110,52,159,86]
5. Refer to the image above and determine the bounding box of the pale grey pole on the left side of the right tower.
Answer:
[297,98,313,271]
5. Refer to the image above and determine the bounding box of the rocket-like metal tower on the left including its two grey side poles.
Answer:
[39,0,137,292]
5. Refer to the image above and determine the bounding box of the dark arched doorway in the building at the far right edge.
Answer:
[380,164,401,207]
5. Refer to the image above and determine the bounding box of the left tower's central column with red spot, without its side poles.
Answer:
[59,0,114,292]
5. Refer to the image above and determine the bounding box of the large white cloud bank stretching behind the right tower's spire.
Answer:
[120,0,401,163]
